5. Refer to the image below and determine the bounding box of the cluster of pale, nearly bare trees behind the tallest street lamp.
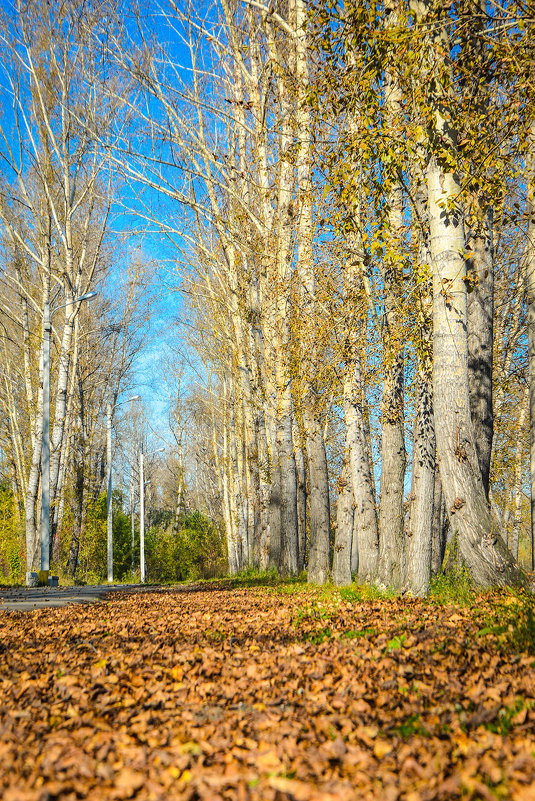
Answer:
[0,2,153,574]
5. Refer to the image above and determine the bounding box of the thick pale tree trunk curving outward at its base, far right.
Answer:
[427,14,526,586]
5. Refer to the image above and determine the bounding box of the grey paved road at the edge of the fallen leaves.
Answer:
[0,584,161,613]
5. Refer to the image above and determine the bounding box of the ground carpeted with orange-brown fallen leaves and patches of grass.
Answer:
[0,582,535,801]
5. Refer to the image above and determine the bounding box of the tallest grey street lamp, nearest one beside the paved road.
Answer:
[41,292,98,581]
